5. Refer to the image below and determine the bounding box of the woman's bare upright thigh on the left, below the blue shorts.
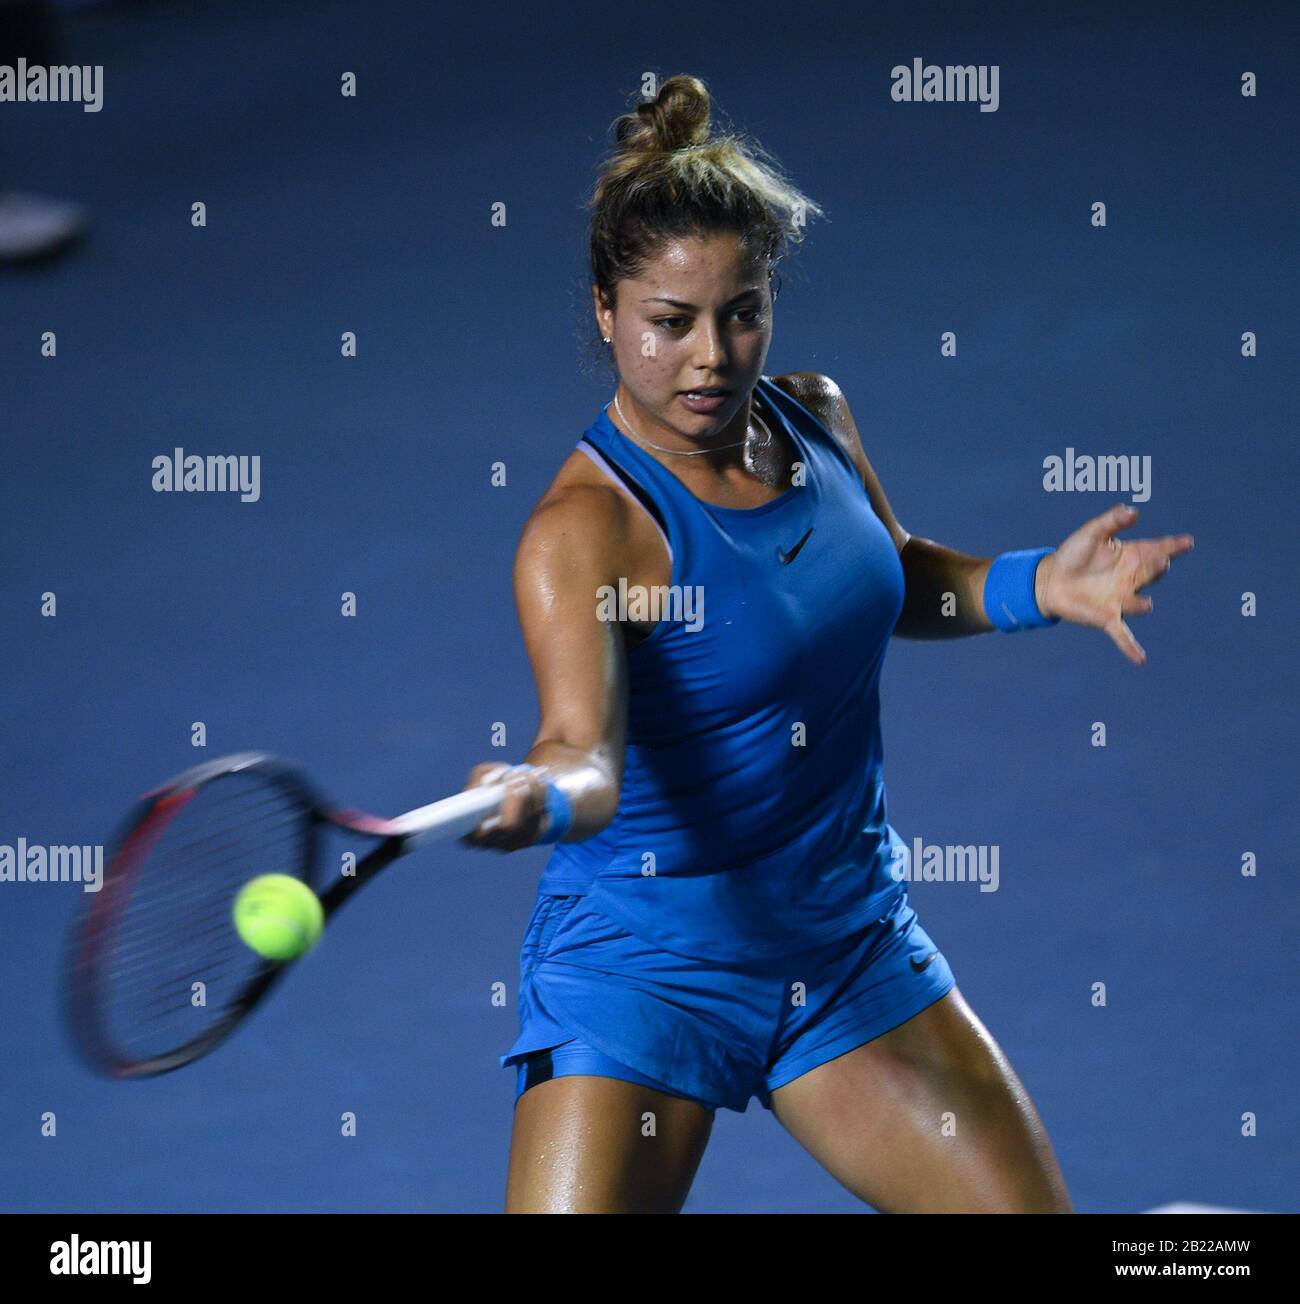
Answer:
[506,1074,713,1214]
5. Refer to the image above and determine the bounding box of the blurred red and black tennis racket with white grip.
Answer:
[64,752,516,1078]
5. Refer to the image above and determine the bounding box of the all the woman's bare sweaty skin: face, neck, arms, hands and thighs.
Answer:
[465,235,1192,1213]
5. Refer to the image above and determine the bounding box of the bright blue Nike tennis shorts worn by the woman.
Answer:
[501,888,954,1114]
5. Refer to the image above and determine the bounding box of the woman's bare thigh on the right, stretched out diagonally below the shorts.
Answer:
[772,987,1073,1213]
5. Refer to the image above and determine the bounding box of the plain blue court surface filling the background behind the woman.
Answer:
[0,0,1300,1213]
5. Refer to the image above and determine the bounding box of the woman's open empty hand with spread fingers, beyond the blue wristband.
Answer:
[1034,503,1193,665]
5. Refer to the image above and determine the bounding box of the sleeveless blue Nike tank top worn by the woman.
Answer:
[540,377,906,961]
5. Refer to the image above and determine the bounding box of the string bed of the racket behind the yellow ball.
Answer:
[84,772,312,1063]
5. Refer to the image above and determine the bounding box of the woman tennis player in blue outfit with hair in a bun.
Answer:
[456,76,1192,1213]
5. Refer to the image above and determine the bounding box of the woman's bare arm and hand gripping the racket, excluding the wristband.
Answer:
[465,485,627,852]
